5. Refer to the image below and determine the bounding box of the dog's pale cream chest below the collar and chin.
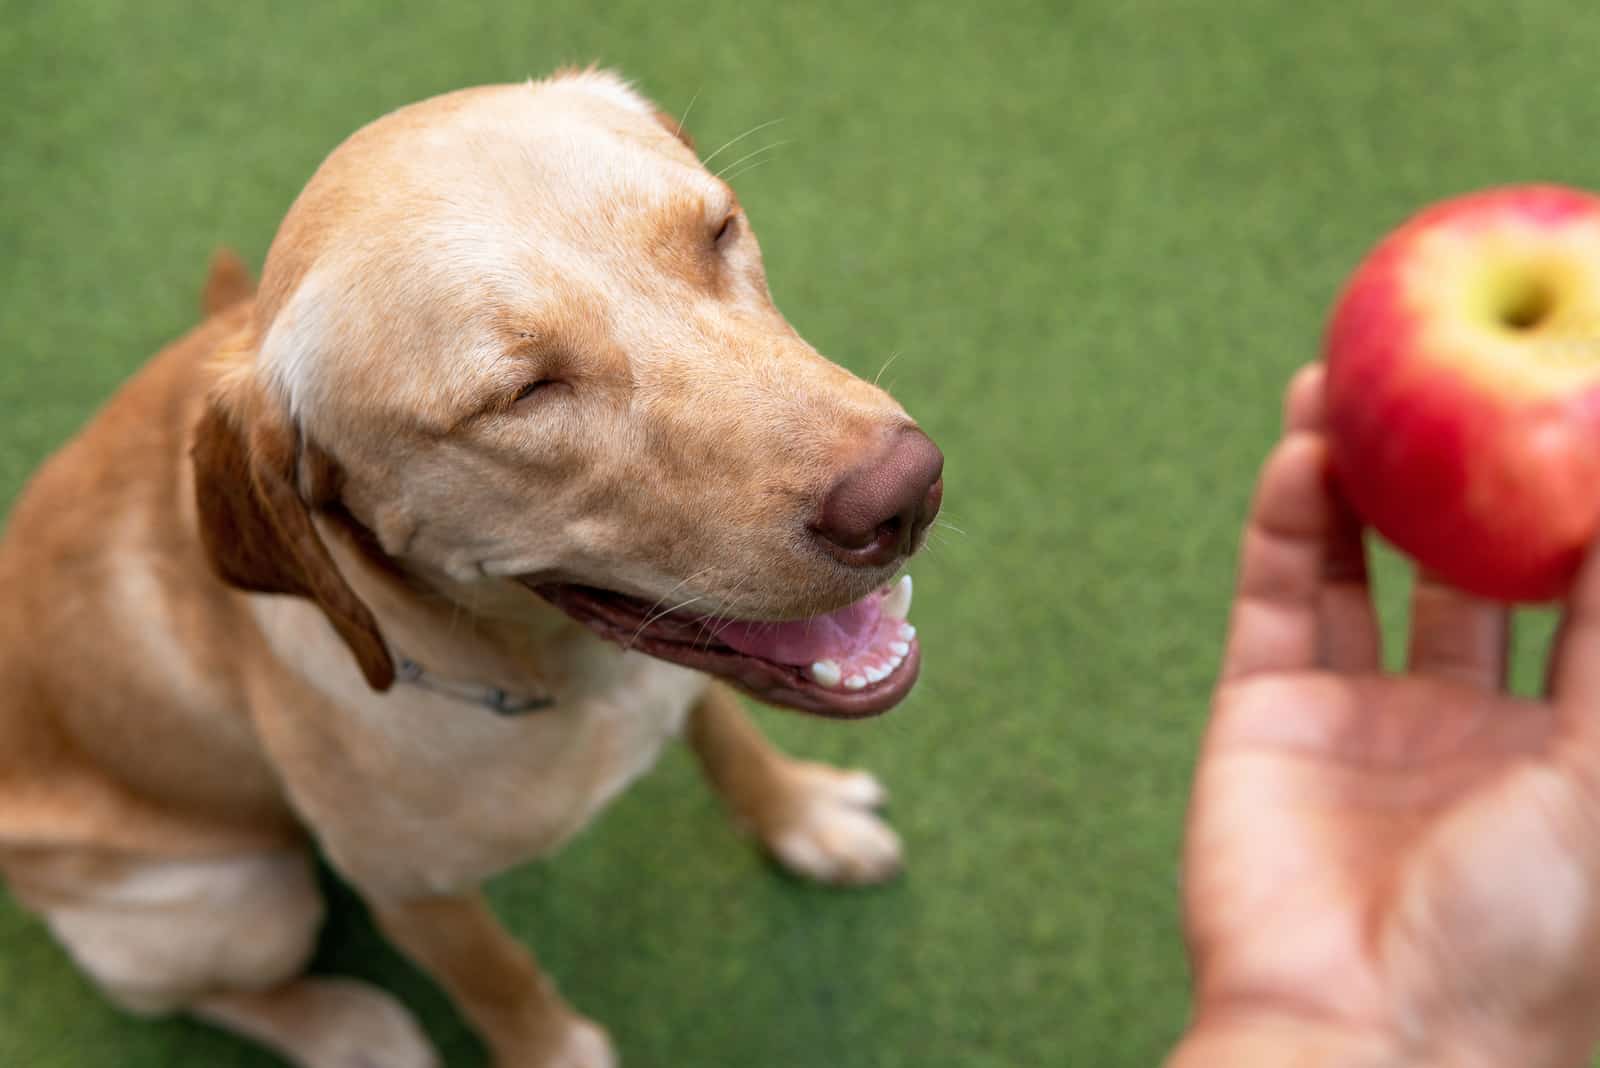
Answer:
[254,607,709,894]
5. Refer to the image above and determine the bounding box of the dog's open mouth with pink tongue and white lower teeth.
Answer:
[531,576,922,718]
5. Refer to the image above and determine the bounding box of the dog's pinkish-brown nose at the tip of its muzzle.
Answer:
[811,427,944,568]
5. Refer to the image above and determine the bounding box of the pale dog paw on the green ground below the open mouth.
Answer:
[762,764,902,886]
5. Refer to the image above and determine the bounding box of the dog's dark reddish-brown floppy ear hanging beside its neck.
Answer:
[192,369,395,691]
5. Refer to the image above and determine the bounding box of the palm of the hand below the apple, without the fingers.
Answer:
[1186,671,1600,1044]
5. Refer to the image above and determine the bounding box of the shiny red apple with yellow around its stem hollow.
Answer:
[1325,185,1600,601]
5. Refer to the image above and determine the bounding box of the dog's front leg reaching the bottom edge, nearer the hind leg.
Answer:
[373,894,618,1068]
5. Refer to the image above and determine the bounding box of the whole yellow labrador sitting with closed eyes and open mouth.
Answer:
[0,72,942,1068]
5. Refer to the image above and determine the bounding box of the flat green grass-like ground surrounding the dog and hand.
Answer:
[0,0,1600,1068]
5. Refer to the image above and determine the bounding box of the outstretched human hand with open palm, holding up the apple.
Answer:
[1170,368,1600,1068]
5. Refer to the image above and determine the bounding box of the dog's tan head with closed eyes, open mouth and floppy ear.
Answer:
[195,72,942,716]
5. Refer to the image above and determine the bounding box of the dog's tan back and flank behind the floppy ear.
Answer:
[0,254,293,870]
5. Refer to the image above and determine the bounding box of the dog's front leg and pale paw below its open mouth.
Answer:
[688,683,901,884]
